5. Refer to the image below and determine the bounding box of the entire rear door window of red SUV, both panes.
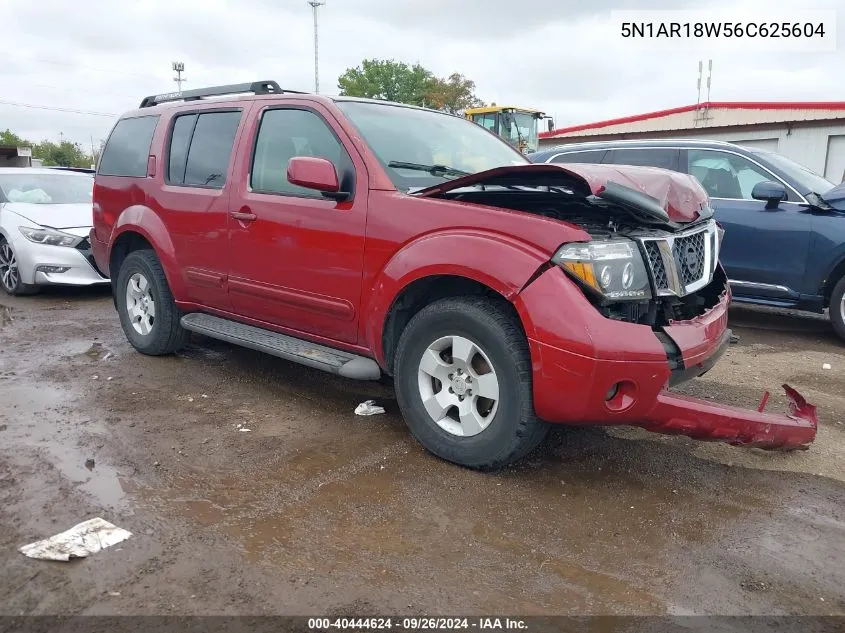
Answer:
[167,111,241,189]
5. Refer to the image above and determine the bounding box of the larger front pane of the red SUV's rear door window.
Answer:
[184,112,241,189]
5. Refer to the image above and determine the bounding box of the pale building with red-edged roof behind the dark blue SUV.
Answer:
[540,101,845,183]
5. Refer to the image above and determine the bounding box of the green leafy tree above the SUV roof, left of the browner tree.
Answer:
[337,59,436,106]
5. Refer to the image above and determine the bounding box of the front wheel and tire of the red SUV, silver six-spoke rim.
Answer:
[395,297,548,470]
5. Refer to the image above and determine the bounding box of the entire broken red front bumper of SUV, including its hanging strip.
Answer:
[516,269,818,450]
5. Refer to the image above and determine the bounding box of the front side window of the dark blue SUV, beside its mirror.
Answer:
[687,149,777,200]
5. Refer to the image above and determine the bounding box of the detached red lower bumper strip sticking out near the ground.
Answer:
[637,385,818,450]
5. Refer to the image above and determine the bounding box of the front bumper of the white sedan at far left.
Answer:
[13,230,109,286]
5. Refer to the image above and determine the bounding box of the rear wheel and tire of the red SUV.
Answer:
[115,250,190,356]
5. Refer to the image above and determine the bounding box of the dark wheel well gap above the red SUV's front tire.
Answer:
[381,275,522,375]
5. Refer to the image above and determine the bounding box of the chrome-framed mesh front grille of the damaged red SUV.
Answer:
[642,220,719,296]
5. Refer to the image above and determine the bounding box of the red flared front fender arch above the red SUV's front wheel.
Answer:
[364,229,551,364]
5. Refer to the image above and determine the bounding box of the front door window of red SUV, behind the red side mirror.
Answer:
[250,110,350,197]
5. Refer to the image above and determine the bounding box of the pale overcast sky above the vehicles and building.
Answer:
[0,0,845,147]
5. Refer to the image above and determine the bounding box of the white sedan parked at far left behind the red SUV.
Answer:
[0,167,109,295]
